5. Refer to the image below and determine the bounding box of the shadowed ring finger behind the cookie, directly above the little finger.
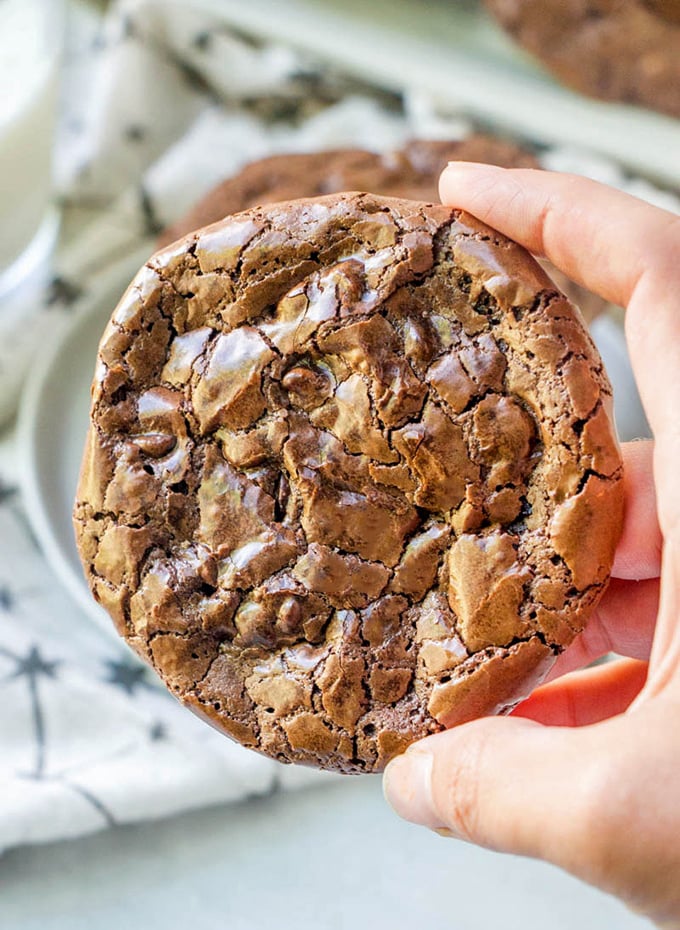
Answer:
[548,578,659,681]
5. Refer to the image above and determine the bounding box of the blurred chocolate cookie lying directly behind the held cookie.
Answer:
[158,134,606,322]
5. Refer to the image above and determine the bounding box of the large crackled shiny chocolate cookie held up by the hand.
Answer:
[75,194,623,772]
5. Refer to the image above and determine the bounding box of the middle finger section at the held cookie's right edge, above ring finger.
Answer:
[612,442,662,581]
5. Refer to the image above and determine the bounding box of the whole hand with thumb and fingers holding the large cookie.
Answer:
[385,163,680,928]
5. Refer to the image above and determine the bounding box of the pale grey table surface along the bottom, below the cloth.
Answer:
[0,778,651,930]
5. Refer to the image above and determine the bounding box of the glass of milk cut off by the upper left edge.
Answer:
[0,0,62,300]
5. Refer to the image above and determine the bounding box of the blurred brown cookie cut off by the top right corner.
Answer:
[485,0,680,116]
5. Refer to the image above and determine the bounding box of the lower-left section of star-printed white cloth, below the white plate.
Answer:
[0,470,340,849]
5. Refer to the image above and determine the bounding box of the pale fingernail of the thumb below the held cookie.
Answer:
[383,752,444,830]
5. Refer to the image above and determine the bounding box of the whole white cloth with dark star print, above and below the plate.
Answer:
[0,0,678,849]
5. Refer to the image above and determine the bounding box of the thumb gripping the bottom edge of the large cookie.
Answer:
[384,717,602,868]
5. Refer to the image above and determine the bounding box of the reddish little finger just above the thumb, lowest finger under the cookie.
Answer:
[513,659,647,727]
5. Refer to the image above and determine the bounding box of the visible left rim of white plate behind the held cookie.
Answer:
[17,245,149,635]
